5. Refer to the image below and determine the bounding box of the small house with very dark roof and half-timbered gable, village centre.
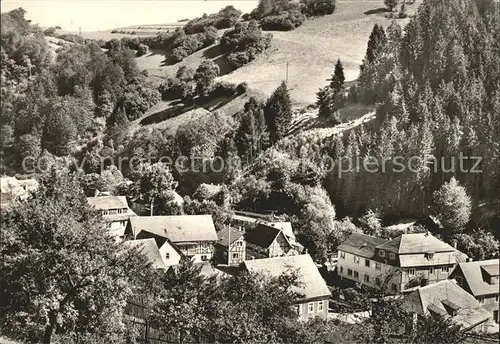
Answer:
[245,223,302,259]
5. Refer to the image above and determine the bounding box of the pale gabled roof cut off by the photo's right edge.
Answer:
[457,259,499,297]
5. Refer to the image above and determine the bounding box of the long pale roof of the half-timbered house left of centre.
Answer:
[130,215,219,243]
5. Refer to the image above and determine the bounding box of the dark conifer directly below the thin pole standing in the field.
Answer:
[264,81,292,143]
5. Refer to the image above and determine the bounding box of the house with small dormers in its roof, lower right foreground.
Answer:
[401,279,491,332]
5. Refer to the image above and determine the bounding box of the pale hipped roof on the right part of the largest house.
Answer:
[377,232,455,254]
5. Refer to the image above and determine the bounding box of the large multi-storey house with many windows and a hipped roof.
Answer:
[337,232,465,293]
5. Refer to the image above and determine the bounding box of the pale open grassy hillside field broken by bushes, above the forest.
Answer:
[137,1,418,105]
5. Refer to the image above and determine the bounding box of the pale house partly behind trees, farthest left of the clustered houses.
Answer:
[87,194,137,241]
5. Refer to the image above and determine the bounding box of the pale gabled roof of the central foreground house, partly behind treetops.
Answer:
[243,254,331,299]
